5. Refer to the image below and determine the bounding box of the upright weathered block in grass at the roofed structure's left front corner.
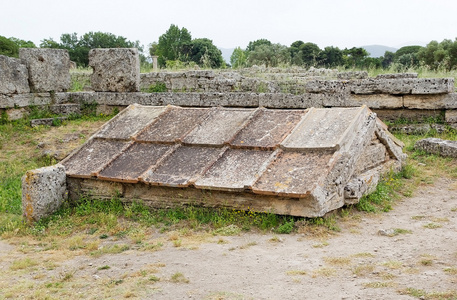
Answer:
[22,164,67,221]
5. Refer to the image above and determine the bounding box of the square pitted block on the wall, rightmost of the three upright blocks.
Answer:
[89,48,140,92]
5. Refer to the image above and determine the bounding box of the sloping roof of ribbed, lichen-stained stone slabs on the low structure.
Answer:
[62,104,401,216]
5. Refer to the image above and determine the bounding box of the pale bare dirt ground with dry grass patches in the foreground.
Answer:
[0,178,457,299]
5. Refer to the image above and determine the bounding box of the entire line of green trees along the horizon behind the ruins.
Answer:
[0,24,457,71]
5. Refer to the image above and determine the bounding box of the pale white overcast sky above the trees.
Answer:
[0,0,457,48]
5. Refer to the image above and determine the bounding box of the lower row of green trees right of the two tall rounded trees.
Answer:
[230,38,457,71]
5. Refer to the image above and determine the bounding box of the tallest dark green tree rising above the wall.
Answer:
[155,24,192,66]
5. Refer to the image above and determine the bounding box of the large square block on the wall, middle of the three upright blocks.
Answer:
[19,48,71,93]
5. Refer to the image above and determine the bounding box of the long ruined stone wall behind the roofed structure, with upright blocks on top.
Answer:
[0,49,457,127]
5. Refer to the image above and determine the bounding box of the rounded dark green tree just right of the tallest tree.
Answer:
[185,38,224,68]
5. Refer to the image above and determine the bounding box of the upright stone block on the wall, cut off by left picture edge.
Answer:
[0,55,30,94]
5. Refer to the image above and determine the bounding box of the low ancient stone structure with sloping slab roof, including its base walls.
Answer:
[62,104,405,217]
